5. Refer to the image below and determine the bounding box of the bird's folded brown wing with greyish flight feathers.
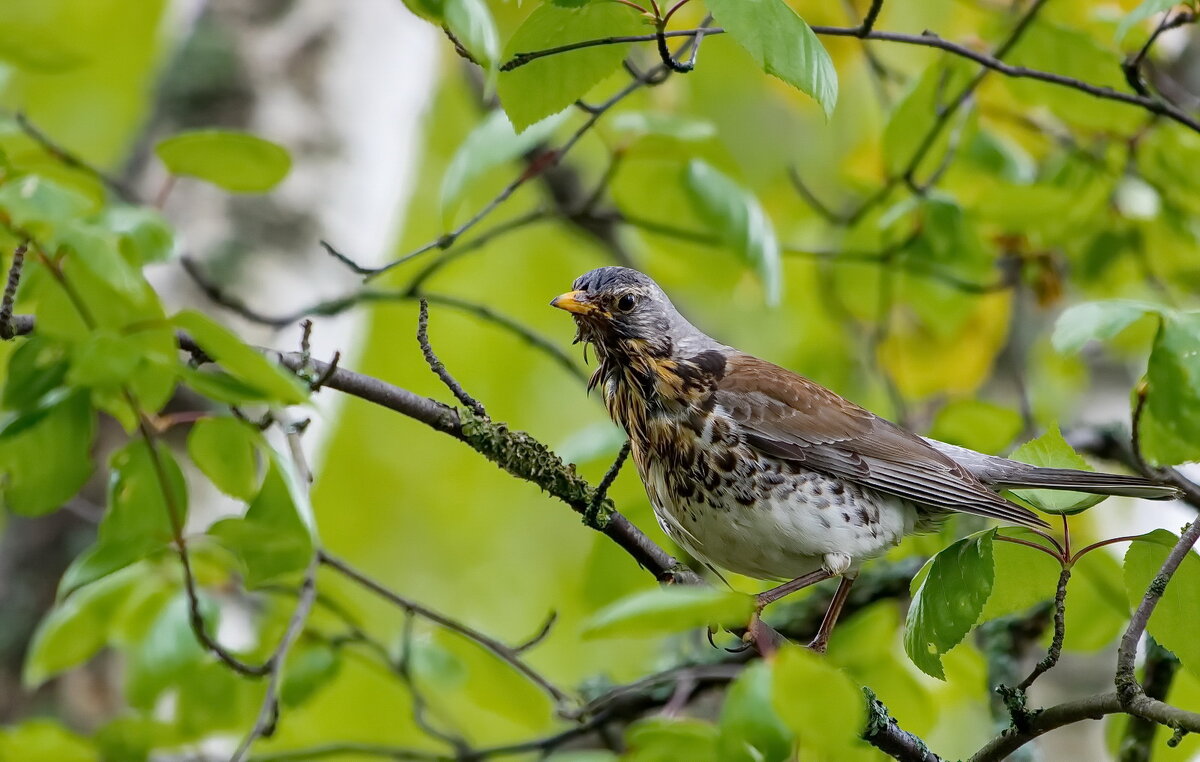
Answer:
[716,354,1046,527]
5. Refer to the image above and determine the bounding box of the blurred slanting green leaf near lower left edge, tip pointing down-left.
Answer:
[22,569,140,689]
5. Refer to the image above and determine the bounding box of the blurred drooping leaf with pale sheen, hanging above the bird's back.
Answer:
[684,158,782,305]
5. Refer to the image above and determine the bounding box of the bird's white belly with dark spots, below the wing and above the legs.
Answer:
[636,444,918,580]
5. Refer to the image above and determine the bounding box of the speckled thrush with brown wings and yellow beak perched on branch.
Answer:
[550,266,1176,652]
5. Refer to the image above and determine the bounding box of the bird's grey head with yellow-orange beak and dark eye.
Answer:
[550,268,695,358]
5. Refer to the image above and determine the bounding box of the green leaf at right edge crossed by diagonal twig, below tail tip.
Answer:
[1124,529,1200,677]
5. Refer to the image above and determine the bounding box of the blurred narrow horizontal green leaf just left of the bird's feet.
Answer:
[583,587,754,637]
